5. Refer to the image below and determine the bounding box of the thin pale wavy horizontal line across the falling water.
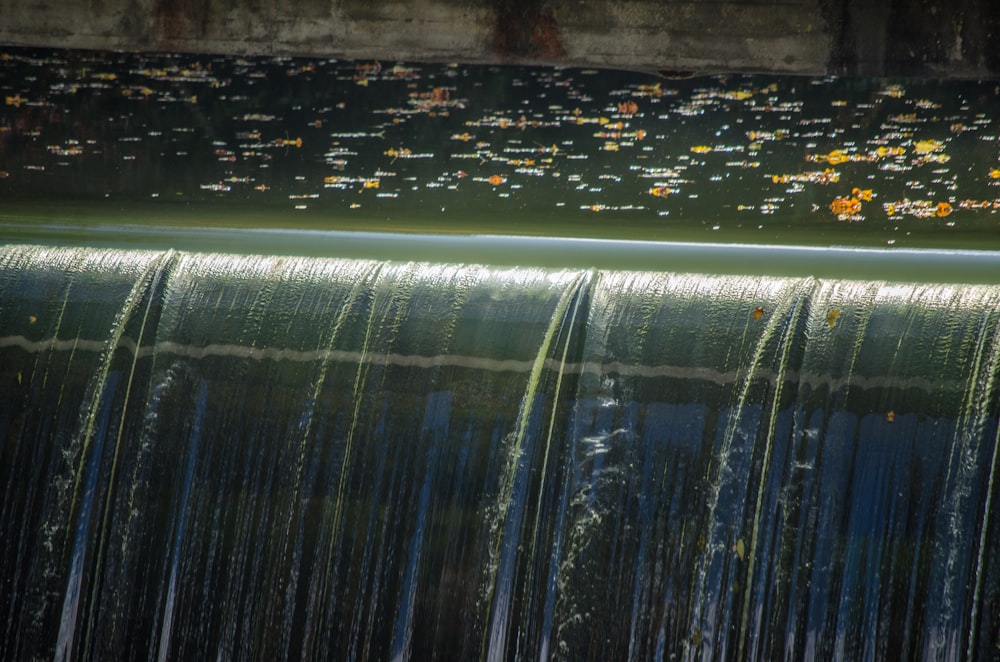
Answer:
[0,335,952,393]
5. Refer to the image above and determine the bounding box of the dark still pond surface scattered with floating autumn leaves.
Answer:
[0,49,1000,248]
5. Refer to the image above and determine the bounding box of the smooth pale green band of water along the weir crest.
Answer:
[0,223,1000,284]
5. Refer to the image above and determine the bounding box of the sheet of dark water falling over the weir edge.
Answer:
[0,246,1000,660]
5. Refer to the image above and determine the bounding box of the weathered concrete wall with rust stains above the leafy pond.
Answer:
[0,0,1000,78]
